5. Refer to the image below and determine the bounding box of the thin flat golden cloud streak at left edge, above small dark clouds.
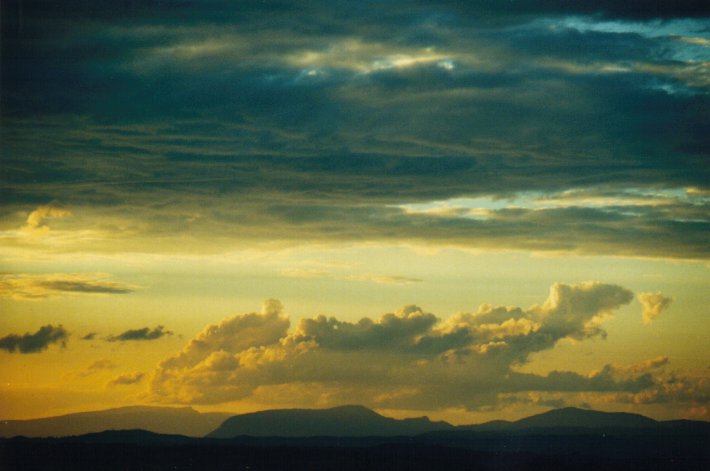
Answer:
[0,273,135,300]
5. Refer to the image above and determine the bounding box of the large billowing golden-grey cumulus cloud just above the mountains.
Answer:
[150,282,650,409]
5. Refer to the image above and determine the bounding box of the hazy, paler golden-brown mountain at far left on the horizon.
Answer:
[0,406,232,437]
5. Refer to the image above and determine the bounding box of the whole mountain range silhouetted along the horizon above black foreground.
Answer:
[0,405,710,438]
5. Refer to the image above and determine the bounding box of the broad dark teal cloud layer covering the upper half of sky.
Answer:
[0,0,710,259]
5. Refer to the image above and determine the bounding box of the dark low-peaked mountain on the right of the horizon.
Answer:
[468,407,660,431]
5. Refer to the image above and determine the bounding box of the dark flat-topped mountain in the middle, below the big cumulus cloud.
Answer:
[207,406,455,438]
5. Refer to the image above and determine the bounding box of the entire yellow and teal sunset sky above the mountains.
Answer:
[0,0,710,424]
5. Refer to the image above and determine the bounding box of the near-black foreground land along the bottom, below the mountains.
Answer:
[0,436,710,471]
